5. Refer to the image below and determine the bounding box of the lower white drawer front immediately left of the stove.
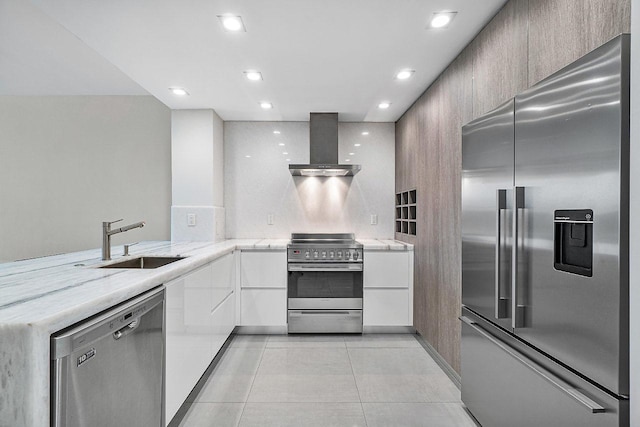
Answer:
[240,288,287,326]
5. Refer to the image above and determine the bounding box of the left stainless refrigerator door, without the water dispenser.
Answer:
[462,100,514,328]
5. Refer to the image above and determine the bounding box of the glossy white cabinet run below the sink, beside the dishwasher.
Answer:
[165,254,235,424]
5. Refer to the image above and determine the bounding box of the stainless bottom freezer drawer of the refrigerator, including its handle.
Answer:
[461,309,629,427]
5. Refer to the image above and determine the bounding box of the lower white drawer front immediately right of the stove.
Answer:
[362,288,412,326]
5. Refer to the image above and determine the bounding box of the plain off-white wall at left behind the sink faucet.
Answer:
[0,96,171,261]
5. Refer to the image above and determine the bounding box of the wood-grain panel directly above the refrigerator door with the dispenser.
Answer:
[529,0,631,86]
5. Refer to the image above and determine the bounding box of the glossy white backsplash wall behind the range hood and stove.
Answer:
[224,122,395,238]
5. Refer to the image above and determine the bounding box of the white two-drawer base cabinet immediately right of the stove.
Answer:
[362,250,413,326]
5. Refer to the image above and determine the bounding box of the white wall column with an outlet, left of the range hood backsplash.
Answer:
[171,109,224,241]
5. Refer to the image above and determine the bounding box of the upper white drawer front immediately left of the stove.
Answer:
[240,251,287,288]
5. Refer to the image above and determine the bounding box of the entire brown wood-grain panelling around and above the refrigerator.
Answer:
[396,0,631,372]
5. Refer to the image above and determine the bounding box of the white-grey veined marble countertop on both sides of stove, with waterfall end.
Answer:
[0,239,413,426]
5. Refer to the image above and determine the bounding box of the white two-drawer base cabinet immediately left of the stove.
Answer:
[240,250,287,327]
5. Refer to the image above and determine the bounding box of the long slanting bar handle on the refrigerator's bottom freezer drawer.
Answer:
[458,316,606,414]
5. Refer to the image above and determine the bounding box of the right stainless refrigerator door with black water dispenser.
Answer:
[515,35,629,395]
